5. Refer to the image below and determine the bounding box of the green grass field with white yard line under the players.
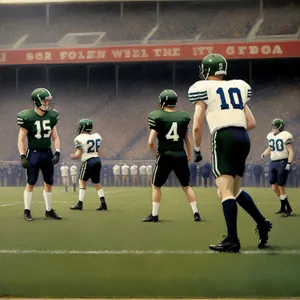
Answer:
[0,187,300,298]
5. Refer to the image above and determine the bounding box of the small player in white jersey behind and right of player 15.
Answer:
[70,119,107,210]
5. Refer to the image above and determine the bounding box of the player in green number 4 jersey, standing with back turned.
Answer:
[142,90,201,222]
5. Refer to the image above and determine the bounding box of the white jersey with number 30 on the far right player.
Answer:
[267,131,294,161]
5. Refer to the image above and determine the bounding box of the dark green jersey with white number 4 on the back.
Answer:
[148,110,191,154]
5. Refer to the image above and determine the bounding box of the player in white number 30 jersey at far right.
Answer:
[261,119,294,217]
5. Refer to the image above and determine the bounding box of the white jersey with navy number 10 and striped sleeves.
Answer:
[188,80,252,134]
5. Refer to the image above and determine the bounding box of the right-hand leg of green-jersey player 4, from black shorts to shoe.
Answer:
[172,153,201,222]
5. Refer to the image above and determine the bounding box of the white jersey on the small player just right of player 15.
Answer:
[74,133,102,162]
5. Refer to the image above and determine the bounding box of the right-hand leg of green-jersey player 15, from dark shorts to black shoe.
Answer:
[39,151,62,220]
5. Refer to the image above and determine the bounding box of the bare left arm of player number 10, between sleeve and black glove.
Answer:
[193,101,206,151]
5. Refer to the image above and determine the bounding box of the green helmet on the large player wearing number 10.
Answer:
[200,54,228,80]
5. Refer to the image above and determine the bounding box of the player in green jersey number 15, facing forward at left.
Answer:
[17,88,61,221]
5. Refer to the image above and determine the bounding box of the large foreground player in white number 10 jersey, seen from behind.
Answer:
[188,54,272,252]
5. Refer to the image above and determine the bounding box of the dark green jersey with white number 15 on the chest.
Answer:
[17,109,59,149]
